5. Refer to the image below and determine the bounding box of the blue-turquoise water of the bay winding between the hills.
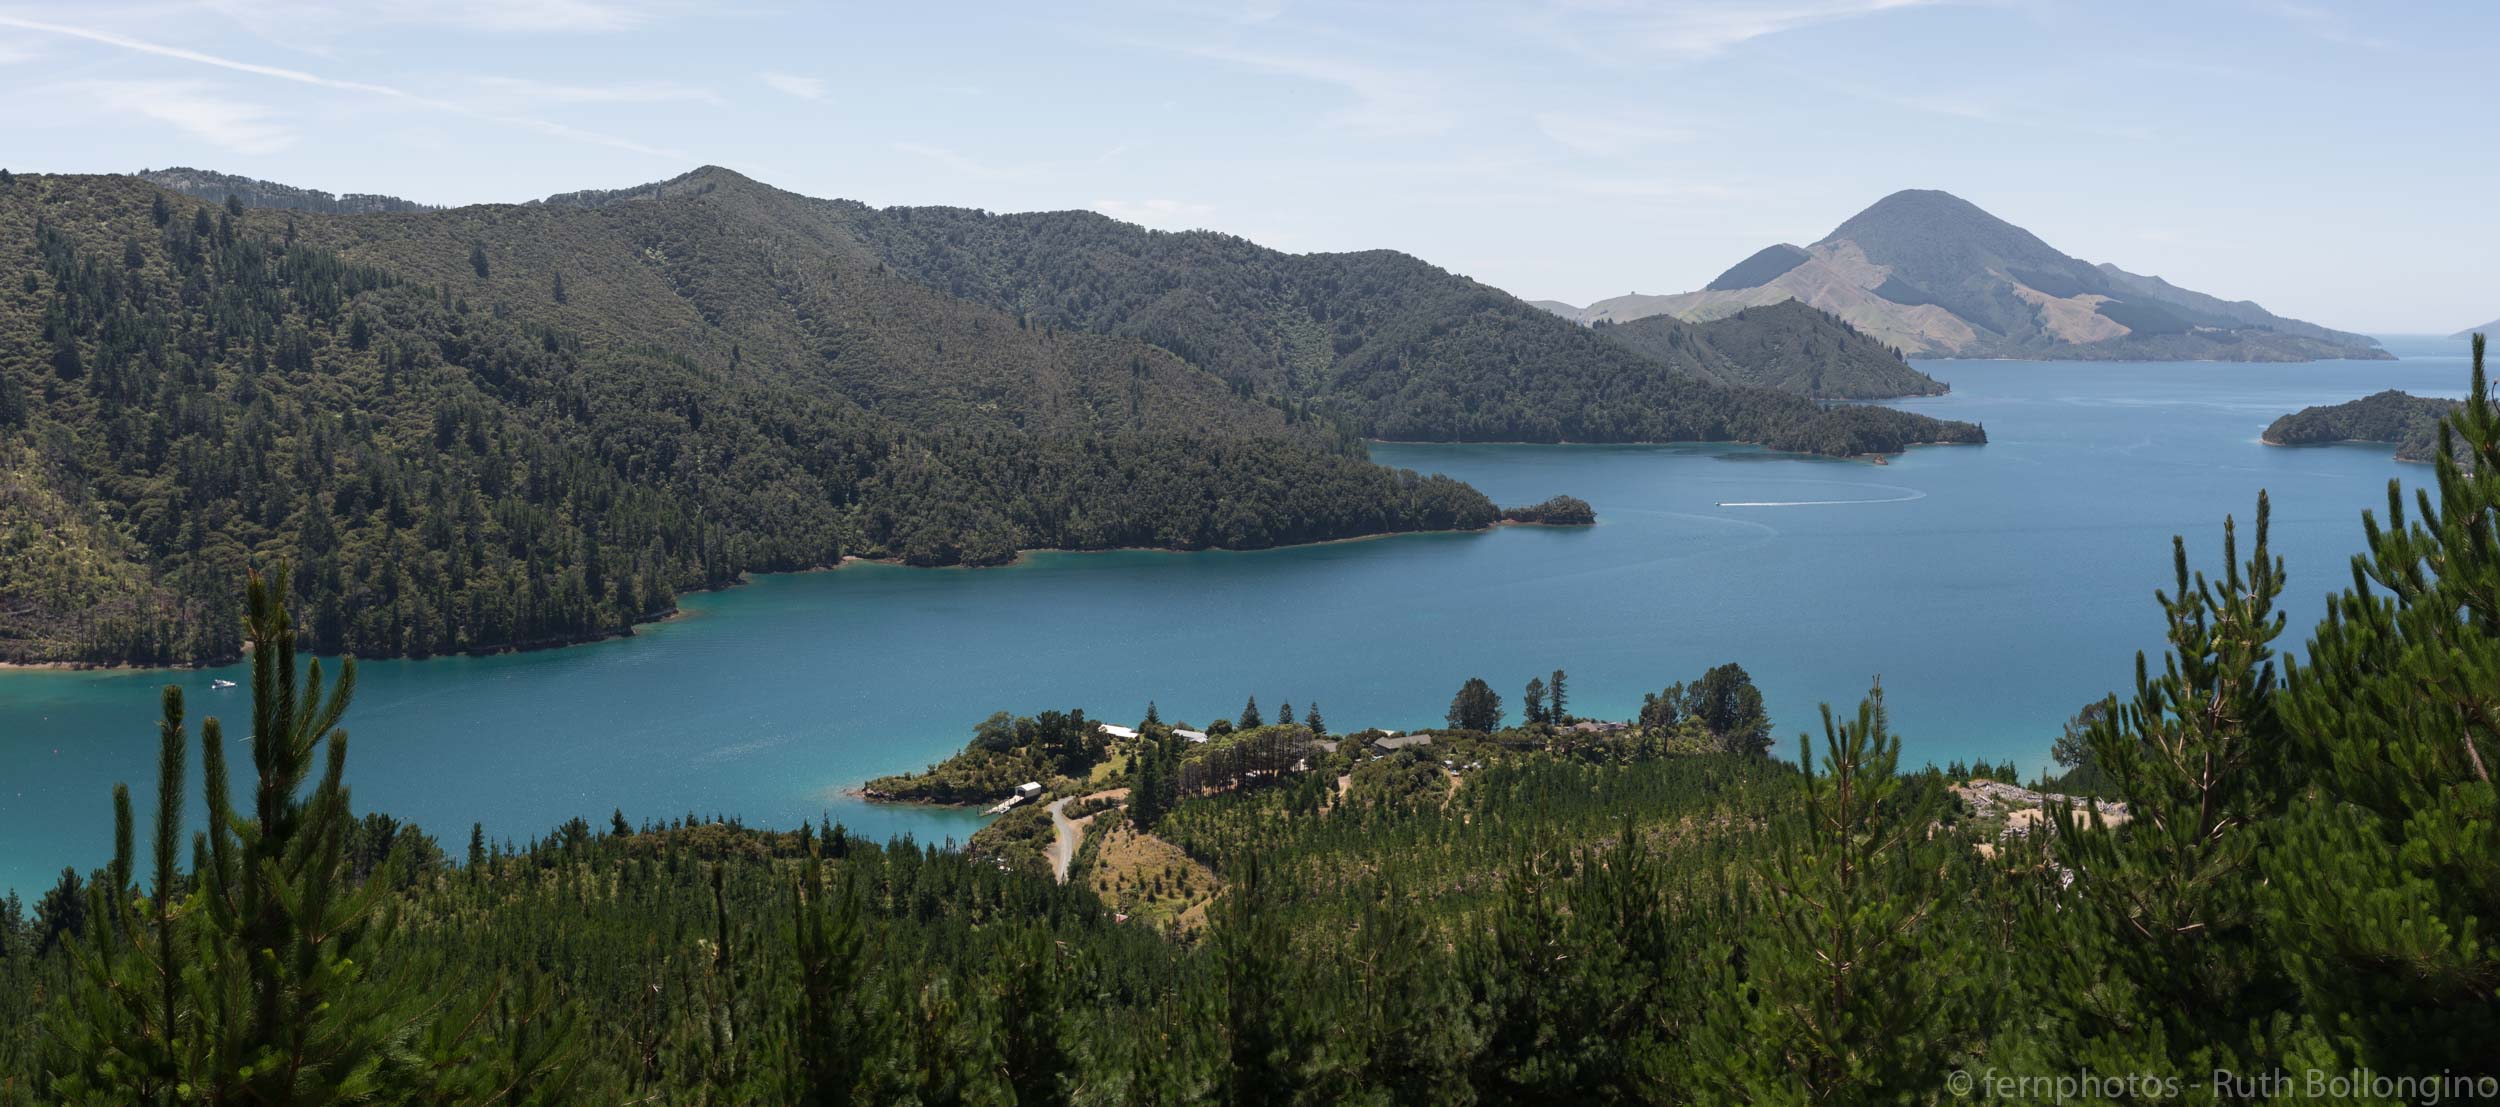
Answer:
[0,342,2465,895]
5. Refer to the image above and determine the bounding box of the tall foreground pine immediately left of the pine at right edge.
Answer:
[2025,495,2295,1089]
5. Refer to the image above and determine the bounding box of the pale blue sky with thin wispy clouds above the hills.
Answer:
[0,0,2500,332]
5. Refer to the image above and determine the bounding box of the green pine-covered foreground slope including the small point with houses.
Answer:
[0,352,2500,1105]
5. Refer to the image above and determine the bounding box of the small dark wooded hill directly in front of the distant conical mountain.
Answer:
[1595,300,1945,400]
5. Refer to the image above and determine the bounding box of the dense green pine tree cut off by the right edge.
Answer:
[2258,335,2500,1072]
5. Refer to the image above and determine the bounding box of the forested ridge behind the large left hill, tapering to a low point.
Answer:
[828,202,1985,455]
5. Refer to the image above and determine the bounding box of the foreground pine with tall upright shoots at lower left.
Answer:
[48,562,540,1107]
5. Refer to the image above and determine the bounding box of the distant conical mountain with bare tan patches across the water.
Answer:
[1558,190,2390,362]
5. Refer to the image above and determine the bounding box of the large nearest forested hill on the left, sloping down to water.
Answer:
[0,175,1495,662]
